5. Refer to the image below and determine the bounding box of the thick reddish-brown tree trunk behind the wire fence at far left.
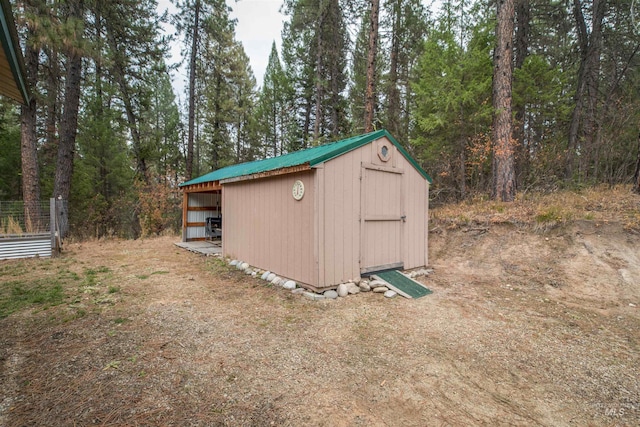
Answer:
[20,28,41,231]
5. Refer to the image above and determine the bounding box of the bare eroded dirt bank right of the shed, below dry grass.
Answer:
[430,221,640,309]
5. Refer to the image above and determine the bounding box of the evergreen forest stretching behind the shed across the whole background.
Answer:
[0,0,640,238]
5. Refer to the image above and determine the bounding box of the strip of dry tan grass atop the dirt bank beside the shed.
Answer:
[431,186,640,233]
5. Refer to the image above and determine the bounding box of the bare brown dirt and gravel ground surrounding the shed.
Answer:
[0,221,640,426]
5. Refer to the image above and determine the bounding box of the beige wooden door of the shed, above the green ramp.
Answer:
[360,164,406,274]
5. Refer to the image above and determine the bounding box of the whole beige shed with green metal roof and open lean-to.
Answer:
[181,130,431,290]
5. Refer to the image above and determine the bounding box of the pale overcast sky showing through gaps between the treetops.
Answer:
[158,0,286,102]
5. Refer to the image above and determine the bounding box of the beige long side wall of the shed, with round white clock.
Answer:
[222,171,317,286]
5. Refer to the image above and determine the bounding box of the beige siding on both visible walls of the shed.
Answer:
[222,138,428,288]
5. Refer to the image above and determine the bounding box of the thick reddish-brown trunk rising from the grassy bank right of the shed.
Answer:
[492,0,516,202]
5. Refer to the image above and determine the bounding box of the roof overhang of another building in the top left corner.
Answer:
[0,0,30,104]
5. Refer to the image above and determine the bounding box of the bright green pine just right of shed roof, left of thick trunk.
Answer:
[411,5,493,199]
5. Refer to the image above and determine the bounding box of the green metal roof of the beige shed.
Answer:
[180,129,432,187]
